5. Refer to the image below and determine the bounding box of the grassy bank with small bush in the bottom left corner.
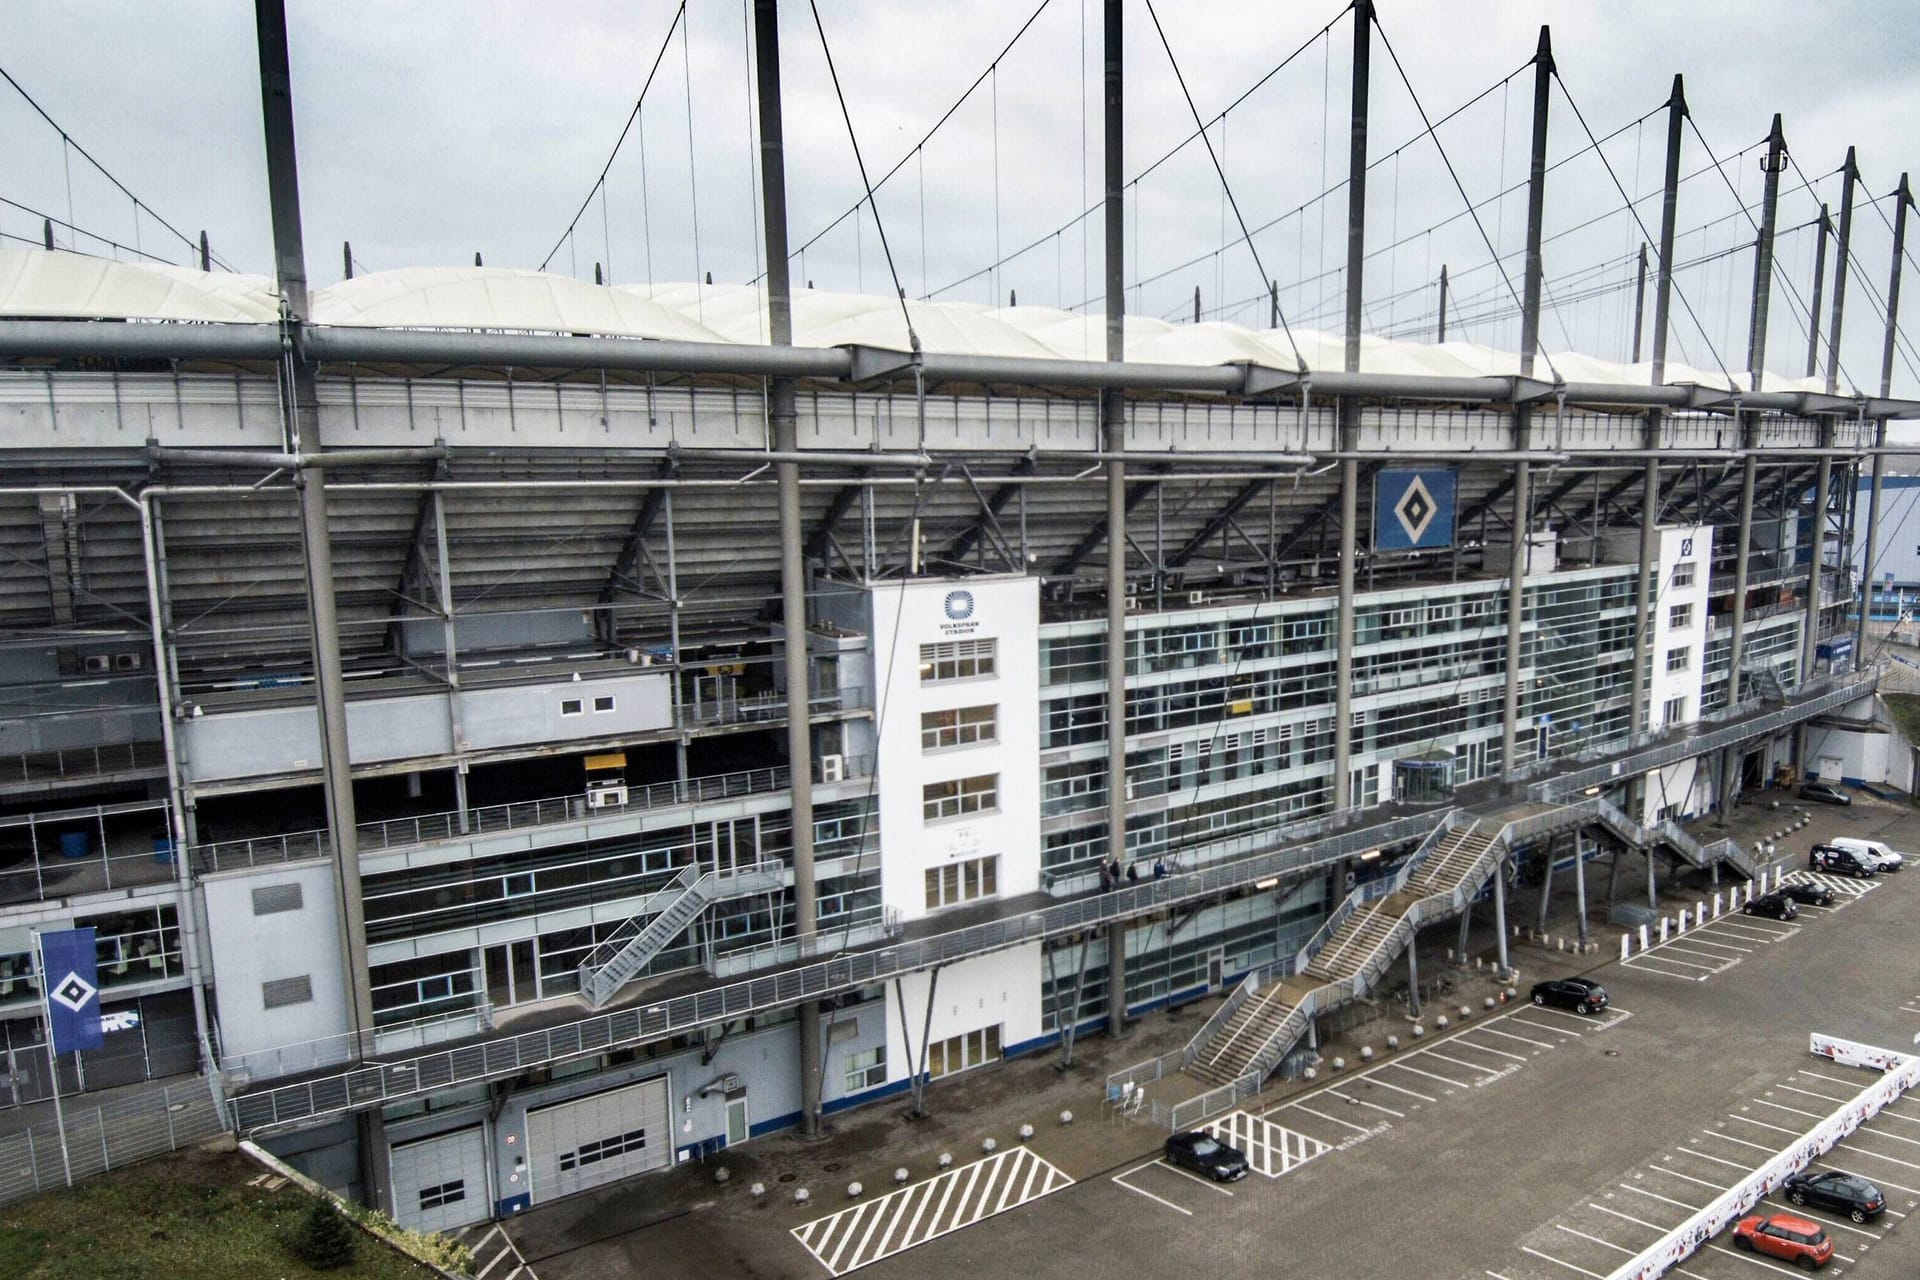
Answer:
[0,1151,432,1280]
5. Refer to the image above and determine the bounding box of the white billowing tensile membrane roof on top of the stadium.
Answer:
[0,249,1853,393]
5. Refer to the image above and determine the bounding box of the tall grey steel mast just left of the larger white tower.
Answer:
[748,0,824,1138]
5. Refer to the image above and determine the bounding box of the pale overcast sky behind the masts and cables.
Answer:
[0,0,1920,395]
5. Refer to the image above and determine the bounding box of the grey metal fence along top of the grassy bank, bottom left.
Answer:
[0,1079,225,1203]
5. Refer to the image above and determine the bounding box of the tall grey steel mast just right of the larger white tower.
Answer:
[1100,0,1127,1036]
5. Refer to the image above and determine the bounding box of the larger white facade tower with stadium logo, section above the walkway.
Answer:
[874,578,1041,919]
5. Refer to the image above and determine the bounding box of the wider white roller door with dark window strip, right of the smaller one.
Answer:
[526,1075,674,1201]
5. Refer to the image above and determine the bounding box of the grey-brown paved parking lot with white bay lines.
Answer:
[833,806,1920,1280]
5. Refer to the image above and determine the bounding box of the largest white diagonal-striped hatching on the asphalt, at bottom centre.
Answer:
[793,1126,1075,1276]
